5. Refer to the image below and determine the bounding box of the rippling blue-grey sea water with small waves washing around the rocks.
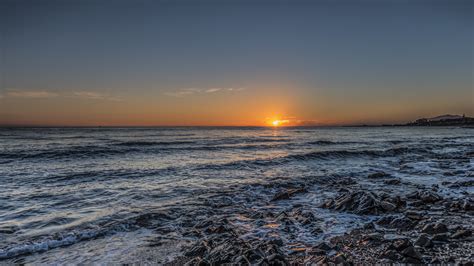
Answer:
[0,127,474,264]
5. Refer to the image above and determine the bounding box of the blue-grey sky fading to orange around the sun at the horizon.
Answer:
[0,0,474,126]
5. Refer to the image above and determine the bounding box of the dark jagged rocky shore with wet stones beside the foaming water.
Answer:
[169,172,474,265]
